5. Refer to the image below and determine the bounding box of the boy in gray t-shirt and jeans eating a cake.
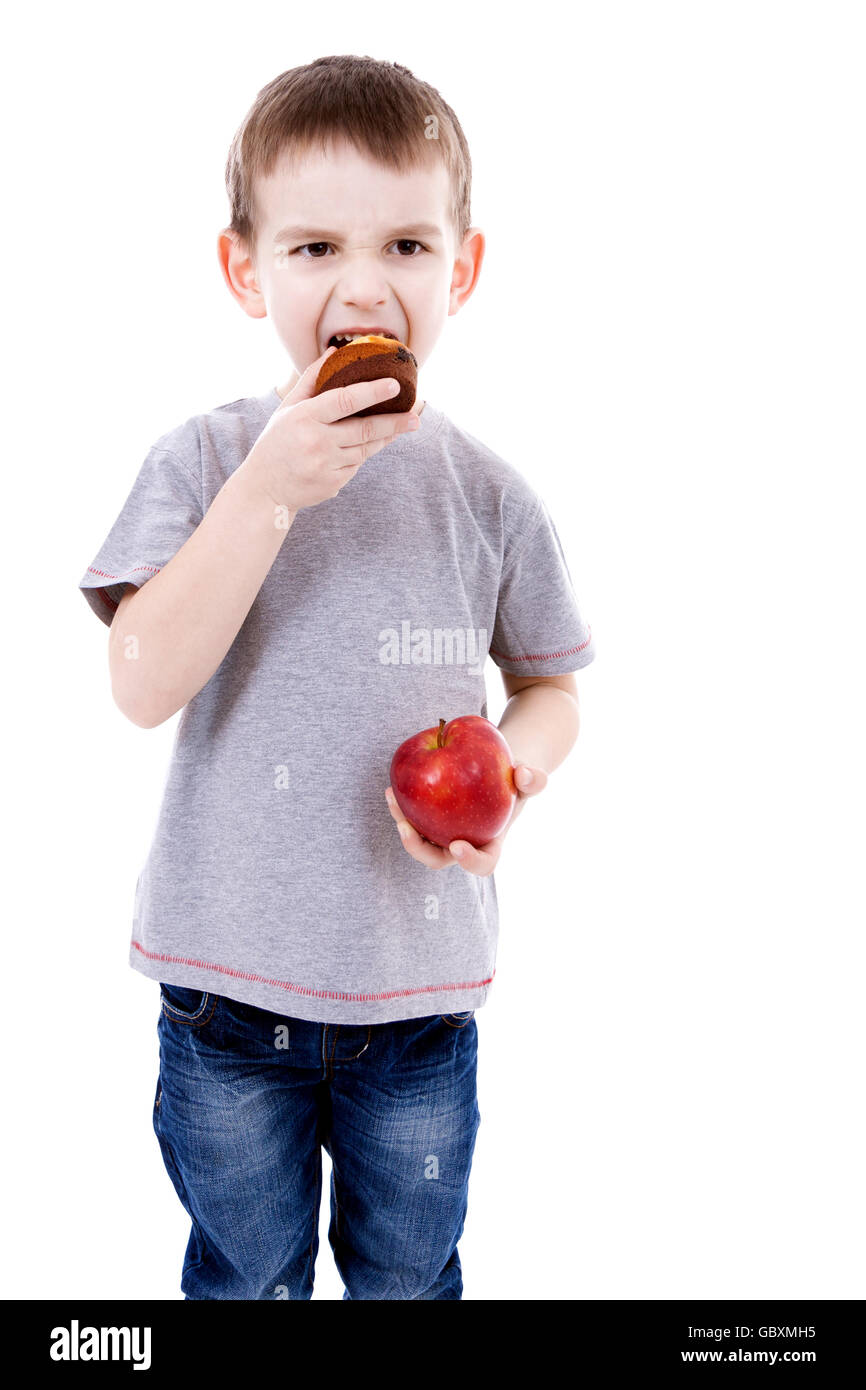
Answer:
[79,56,595,1300]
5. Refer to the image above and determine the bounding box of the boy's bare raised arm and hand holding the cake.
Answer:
[108,364,417,728]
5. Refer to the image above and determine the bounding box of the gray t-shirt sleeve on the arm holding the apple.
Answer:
[489,498,595,676]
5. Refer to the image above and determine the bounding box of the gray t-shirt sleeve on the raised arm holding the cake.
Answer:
[78,443,204,627]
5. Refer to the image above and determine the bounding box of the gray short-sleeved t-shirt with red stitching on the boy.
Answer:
[79,391,595,1023]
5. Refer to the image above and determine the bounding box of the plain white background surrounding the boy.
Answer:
[0,0,866,1300]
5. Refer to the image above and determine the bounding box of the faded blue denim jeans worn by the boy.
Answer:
[153,984,481,1300]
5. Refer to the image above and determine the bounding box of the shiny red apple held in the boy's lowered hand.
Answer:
[391,714,517,849]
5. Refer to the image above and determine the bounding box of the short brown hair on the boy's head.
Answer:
[225,54,473,266]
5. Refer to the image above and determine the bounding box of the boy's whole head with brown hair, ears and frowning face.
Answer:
[218,56,484,386]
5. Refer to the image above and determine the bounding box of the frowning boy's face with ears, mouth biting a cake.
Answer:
[220,142,484,386]
